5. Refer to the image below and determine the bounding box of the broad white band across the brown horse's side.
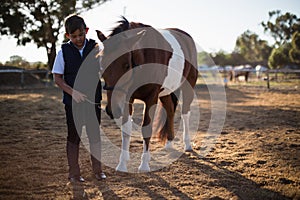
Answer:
[159,30,185,97]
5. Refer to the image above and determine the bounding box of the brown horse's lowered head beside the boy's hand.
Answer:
[97,18,143,118]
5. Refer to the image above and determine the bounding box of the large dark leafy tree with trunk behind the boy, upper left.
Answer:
[0,0,107,69]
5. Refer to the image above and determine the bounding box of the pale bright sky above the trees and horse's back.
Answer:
[0,0,300,63]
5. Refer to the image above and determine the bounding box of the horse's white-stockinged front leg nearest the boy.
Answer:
[116,115,132,172]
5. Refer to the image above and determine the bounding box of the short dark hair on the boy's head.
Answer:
[65,14,86,34]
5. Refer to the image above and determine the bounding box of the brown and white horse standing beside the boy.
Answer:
[96,17,198,172]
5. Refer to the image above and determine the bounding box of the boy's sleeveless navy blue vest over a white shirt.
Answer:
[61,40,102,105]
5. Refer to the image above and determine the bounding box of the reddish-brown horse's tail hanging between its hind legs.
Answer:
[153,90,179,143]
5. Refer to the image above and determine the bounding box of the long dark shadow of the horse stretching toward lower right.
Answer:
[125,152,289,200]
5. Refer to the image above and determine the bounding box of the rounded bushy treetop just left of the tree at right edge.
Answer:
[235,30,272,64]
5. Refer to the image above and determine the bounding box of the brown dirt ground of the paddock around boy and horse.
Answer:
[0,81,300,200]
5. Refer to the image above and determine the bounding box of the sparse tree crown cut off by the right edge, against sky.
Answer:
[261,10,300,47]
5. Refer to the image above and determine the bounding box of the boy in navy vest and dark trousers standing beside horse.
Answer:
[52,14,106,182]
